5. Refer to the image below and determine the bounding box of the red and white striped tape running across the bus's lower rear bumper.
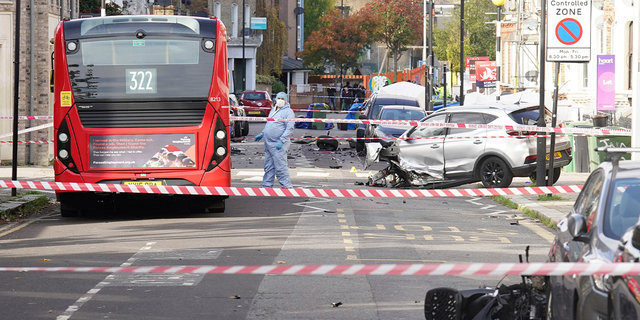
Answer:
[0,180,582,198]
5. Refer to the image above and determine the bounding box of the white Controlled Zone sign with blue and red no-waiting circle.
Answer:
[547,0,591,62]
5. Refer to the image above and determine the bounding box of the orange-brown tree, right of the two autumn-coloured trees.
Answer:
[372,0,423,81]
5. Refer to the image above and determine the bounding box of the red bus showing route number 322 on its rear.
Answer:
[52,16,231,216]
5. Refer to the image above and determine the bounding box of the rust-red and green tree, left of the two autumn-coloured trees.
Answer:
[299,5,379,77]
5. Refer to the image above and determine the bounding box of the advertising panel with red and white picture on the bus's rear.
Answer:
[89,134,196,169]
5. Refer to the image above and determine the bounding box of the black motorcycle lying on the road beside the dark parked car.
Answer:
[424,246,547,320]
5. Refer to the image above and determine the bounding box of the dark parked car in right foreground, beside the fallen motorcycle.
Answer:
[547,148,640,320]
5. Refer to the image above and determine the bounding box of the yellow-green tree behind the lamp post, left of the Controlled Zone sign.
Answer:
[433,0,496,73]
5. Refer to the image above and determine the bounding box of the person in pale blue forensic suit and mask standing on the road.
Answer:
[255,92,296,189]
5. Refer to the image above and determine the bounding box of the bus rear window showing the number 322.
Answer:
[67,35,215,101]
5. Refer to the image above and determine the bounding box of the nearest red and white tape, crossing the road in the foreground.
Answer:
[0,262,640,276]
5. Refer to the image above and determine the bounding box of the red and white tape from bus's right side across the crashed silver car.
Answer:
[230,116,631,136]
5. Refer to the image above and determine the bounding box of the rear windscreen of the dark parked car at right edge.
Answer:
[604,179,640,239]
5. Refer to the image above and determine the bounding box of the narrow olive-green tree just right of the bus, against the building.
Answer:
[256,0,287,76]
